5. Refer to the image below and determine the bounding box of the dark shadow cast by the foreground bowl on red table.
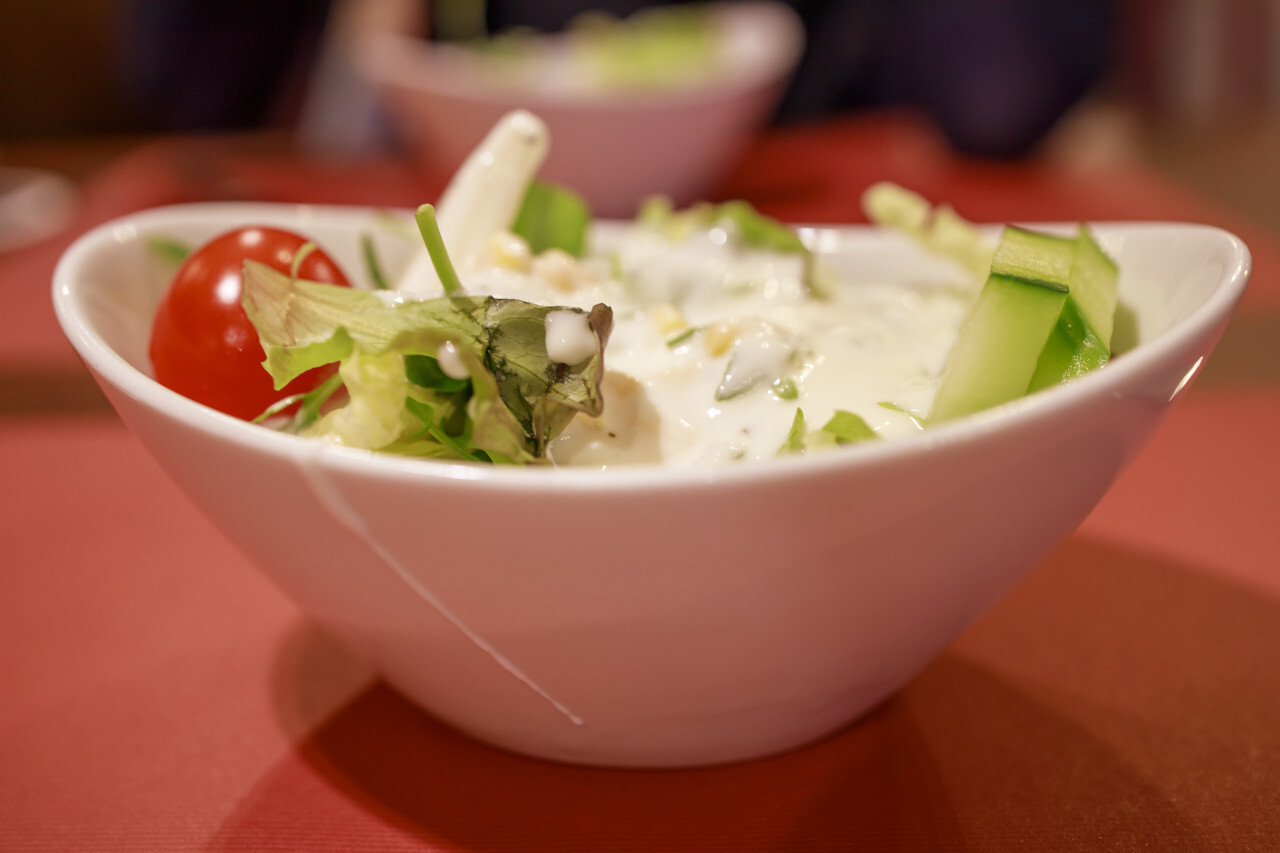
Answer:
[207,537,1280,853]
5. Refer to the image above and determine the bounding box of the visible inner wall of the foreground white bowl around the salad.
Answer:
[55,202,1249,438]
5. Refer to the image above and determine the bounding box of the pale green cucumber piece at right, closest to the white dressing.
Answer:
[929,225,1075,423]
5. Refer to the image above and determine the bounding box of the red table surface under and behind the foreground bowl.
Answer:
[0,119,1280,853]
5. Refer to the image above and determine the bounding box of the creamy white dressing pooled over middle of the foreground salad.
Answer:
[396,225,968,469]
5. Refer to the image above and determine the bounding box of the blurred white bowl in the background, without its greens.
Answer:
[355,3,804,216]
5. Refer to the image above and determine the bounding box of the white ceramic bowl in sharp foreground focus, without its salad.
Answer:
[54,204,1249,766]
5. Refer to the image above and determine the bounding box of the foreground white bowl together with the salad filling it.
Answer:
[54,114,1249,766]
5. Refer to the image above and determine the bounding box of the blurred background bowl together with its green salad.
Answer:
[353,3,804,216]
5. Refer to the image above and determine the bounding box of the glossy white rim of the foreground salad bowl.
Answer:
[52,201,1252,493]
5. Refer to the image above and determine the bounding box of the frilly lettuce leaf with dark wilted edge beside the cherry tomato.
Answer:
[242,261,613,462]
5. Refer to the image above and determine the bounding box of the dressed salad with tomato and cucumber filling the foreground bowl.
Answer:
[151,111,1117,469]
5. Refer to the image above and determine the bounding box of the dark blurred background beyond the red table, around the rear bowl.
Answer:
[0,0,1280,227]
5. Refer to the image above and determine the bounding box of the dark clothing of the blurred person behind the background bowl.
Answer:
[123,0,1115,158]
